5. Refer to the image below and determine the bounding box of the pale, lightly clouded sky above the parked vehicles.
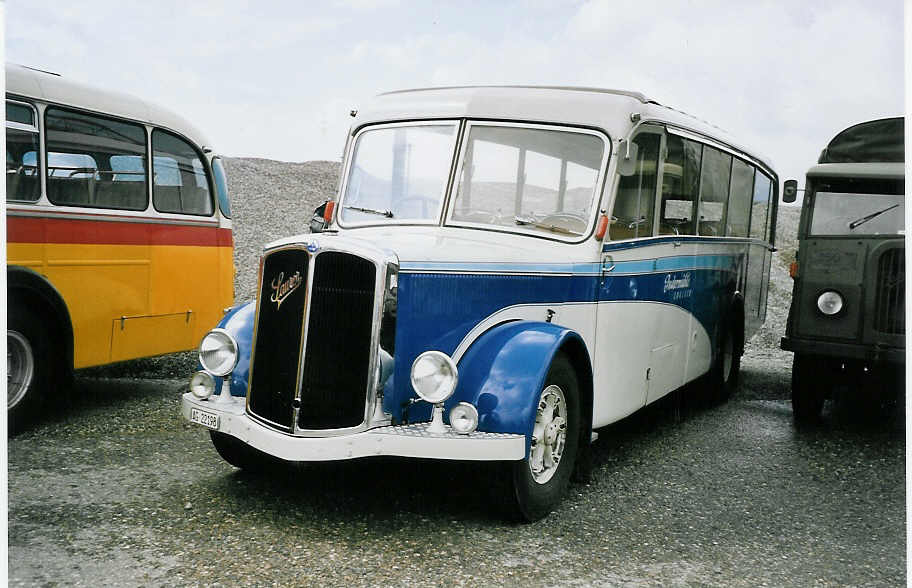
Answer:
[5,0,904,184]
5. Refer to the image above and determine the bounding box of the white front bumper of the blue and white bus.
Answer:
[181,392,526,461]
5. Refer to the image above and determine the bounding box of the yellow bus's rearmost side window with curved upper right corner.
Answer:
[152,129,213,216]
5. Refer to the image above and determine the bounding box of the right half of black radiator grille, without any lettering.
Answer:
[298,251,377,429]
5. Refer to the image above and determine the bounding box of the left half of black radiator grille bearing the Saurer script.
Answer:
[249,249,310,431]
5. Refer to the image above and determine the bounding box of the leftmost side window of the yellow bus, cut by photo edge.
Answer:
[6,102,41,202]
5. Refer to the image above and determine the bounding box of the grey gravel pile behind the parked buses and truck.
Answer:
[81,158,800,378]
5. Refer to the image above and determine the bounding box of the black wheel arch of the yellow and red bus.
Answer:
[6,265,73,375]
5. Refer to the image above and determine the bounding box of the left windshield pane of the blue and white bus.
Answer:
[341,123,457,224]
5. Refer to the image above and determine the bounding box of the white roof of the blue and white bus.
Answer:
[354,86,772,171]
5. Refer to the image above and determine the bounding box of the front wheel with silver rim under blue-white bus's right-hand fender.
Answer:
[507,354,580,522]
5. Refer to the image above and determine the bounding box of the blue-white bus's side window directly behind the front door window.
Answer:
[659,134,703,235]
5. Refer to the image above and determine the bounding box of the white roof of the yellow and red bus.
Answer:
[6,63,212,149]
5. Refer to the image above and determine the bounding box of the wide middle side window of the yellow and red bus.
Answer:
[45,108,148,210]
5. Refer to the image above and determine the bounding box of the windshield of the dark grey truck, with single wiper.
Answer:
[811,192,905,236]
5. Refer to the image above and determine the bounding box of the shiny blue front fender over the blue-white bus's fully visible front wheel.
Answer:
[447,321,591,454]
